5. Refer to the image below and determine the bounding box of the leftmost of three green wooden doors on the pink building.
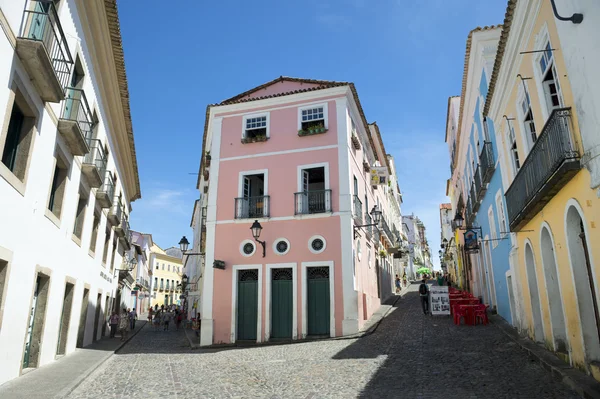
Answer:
[236,269,258,341]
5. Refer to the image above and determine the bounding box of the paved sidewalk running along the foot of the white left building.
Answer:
[0,319,146,399]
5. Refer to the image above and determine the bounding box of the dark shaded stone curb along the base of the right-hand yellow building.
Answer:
[490,316,600,399]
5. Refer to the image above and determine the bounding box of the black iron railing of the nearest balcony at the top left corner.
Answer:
[19,0,73,88]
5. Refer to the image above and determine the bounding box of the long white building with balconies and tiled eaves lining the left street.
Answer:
[0,0,140,383]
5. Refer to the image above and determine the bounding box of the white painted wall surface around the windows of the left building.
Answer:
[0,0,135,384]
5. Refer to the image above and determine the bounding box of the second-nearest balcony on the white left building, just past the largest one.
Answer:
[58,87,93,156]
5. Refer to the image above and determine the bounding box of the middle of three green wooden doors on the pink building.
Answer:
[271,269,294,338]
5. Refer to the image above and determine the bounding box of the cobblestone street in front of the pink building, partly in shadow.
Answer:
[69,285,578,399]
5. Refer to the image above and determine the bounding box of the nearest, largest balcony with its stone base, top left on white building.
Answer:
[15,0,73,103]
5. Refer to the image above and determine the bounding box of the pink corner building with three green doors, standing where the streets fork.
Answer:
[194,77,400,345]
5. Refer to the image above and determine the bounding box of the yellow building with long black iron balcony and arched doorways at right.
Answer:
[483,0,600,379]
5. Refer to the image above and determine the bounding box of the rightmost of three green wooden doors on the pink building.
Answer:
[307,267,330,336]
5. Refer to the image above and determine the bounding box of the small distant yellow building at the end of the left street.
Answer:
[150,244,183,307]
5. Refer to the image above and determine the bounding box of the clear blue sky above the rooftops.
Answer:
[124,0,506,264]
